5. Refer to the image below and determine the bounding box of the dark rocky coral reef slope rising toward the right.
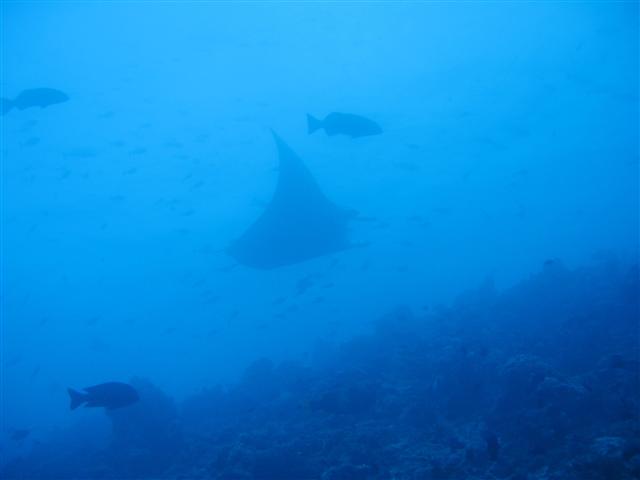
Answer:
[1,262,640,480]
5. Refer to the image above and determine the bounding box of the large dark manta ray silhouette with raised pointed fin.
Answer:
[227,131,354,269]
